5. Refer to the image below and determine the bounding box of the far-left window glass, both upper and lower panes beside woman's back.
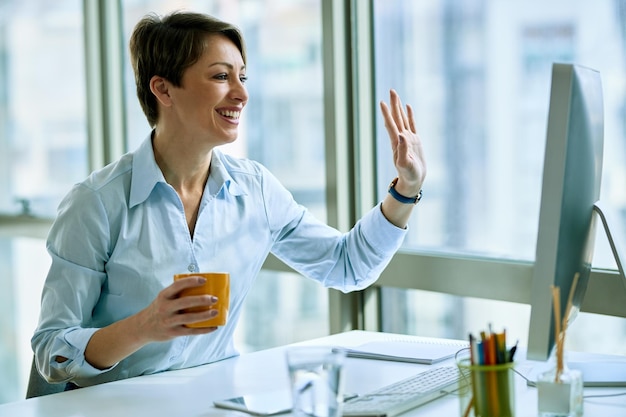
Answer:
[0,0,87,402]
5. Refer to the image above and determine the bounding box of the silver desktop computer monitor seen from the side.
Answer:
[526,63,626,381]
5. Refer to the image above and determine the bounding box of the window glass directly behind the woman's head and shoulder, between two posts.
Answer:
[123,0,329,350]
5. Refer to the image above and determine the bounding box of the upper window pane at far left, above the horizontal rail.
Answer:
[0,0,87,216]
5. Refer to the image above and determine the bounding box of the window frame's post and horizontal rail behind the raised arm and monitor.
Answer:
[323,0,626,332]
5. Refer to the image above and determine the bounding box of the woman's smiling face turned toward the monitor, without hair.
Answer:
[158,34,248,147]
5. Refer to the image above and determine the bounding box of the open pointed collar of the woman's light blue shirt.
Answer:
[129,133,245,208]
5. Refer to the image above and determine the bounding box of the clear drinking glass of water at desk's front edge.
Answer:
[287,346,346,417]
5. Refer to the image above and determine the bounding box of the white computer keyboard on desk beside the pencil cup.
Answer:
[343,366,461,417]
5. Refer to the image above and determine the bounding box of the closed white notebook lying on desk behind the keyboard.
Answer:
[347,339,469,365]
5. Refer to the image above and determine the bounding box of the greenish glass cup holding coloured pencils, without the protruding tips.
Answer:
[457,358,515,417]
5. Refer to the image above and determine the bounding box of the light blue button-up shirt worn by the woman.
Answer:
[31,137,406,386]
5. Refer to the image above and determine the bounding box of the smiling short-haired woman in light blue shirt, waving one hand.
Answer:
[32,12,426,386]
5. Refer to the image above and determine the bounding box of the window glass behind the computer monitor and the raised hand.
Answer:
[374,0,626,351]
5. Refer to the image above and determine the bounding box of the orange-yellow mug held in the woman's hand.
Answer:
[174,272,230,327]
